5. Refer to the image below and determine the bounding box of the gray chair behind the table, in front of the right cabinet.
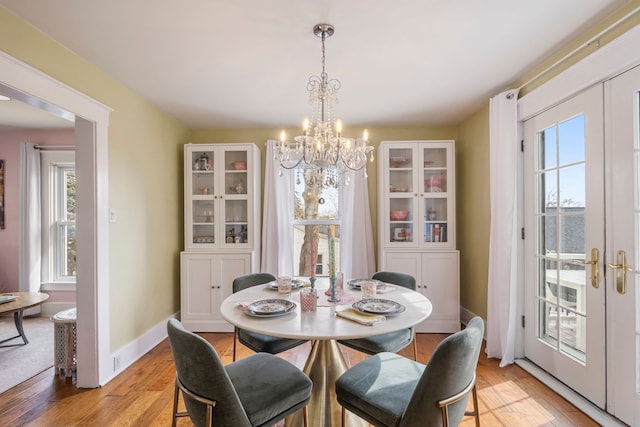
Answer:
[338,271,418,361]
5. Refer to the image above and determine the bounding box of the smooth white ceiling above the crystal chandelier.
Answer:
[0,0,628,128]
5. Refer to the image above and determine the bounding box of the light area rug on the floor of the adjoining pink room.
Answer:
[0,315,53,393]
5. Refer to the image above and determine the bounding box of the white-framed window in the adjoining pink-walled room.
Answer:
[41,151,76,289]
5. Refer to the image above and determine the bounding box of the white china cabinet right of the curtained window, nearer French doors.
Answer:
[378,140,460,332]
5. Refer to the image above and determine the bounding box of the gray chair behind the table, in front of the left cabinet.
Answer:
[233,273,308,361]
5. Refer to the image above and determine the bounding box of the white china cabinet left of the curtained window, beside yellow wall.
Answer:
[180,143,261,332]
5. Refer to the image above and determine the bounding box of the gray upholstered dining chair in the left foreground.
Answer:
[167,319,312,427]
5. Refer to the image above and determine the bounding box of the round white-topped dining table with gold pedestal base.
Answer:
[220,285,432,427]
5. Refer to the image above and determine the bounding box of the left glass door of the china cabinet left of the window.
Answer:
[190,150,216,245]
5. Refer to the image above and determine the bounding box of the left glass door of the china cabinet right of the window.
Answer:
[386,147,418,245]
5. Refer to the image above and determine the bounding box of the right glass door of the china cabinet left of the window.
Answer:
[222,150,250,245]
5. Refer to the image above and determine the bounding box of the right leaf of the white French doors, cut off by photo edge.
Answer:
[605,63,640,426]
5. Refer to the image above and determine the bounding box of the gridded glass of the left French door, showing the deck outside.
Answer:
[536,115,587,361]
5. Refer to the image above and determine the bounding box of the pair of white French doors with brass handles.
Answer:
[524,67,640,426]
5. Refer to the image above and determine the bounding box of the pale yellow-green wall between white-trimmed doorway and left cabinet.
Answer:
[0,7,188,351]
